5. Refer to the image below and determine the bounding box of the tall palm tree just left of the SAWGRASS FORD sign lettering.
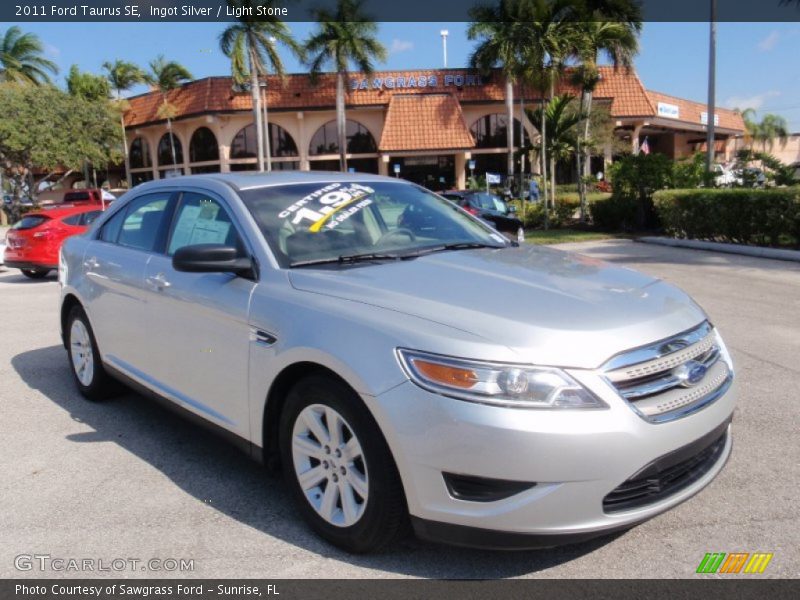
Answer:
[305,0,386,172]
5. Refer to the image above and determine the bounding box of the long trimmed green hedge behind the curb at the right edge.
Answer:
[653,187,800,246]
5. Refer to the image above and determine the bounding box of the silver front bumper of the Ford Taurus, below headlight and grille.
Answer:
[365,371,736,548]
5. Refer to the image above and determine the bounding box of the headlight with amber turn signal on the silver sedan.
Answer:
[397,348,608,408]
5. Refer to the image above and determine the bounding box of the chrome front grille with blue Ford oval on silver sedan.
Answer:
[603,322,733,423]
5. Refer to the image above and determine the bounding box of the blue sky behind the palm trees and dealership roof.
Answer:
[20,23,800,132]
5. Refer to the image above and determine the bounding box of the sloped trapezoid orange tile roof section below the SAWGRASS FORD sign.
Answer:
[378,94,475,152]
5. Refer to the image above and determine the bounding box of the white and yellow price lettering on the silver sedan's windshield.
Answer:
[278,183,375,233]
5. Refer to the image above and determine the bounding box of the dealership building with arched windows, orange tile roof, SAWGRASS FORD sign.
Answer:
[125,67,744,189]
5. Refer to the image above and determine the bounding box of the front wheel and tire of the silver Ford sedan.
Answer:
[279,375,410,553]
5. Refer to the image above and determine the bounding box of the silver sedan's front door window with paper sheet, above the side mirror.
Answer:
[167,192,244,256]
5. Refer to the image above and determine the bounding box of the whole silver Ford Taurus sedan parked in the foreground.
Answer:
[59,172,734,552]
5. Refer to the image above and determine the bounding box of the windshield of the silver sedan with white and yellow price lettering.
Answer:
[240,181,508,267]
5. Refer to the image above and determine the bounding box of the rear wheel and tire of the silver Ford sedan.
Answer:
[65,306,120,401]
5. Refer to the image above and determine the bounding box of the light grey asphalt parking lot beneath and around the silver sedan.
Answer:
[0,240,800,578]
